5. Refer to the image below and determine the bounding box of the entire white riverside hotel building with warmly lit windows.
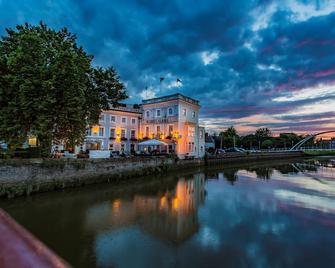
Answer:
[82,94,205,158]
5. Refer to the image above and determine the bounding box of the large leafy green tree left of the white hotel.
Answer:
[0,23,127,155]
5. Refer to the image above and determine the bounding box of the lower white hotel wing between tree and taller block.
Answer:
[84,104,142,152]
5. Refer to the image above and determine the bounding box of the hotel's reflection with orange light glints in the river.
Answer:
[86,173,205,243]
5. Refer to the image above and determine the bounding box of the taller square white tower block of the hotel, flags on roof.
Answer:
[140,94,205,158]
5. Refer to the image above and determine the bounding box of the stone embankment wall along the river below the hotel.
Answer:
[0,152,305,198]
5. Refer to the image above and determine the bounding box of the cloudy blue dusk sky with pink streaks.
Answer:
[0,0,335,134]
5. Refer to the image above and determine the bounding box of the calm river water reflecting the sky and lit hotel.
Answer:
[0,159,335,268]
